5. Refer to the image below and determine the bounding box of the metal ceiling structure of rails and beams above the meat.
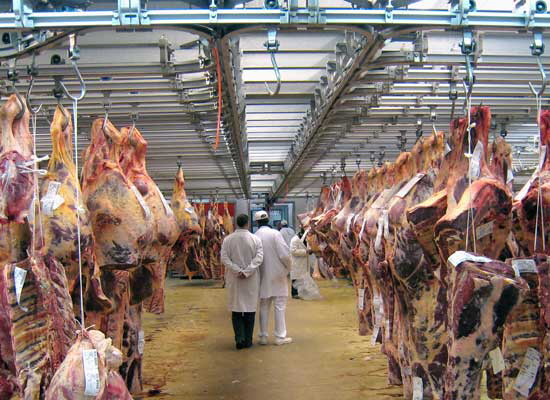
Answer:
[0,0,550,198]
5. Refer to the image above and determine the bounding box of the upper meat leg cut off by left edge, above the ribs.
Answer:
[0,94,34,224]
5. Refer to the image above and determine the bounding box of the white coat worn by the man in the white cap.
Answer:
[256,226,292,299]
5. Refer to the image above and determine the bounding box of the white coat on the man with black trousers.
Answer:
[221,228,264,312]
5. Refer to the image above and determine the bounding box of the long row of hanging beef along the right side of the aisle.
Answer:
[300,106,550,400]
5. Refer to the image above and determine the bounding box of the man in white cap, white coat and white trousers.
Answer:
[254,211,292,345]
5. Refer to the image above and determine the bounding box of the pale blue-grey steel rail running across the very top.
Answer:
[0,5,550,30]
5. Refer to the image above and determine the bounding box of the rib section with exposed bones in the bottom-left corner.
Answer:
[0,255,77,399]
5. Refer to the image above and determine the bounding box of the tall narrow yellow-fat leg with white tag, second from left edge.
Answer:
[39,106,110,315]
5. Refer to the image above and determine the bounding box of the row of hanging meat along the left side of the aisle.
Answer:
[0,95,226,399]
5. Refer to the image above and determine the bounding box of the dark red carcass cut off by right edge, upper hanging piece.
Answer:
[512,110,550,256]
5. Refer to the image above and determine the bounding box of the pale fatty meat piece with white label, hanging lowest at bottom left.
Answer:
[46,330,132,400]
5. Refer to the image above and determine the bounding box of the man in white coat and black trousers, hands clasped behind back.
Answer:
[221,214,264,350]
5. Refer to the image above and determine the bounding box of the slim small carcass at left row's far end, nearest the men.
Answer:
[170,165,202,279]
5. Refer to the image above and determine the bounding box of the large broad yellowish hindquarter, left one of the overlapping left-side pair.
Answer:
[82,118,153,269]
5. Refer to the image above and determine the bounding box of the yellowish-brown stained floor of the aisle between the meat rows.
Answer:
[140,279,402,400]
